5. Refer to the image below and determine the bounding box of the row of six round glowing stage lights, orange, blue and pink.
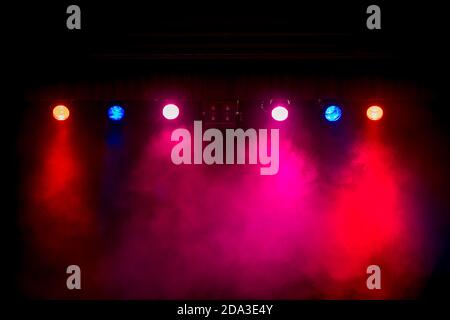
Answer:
[53,103,383,122]
